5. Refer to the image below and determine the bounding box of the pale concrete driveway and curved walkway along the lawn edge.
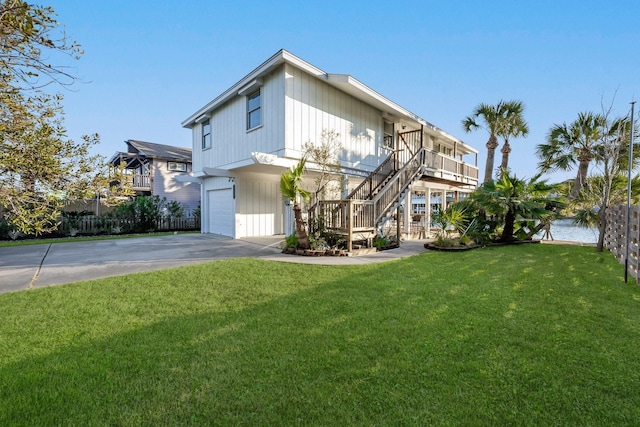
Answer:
[0,233,425,292]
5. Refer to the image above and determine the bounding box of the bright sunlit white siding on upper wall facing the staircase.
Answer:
[285,64,384,169]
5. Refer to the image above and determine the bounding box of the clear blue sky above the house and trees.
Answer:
[51,0,640,180]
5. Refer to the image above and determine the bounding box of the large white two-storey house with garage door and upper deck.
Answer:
[182,50,478,249]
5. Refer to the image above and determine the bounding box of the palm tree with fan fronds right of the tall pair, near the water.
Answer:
[537,112,607,201]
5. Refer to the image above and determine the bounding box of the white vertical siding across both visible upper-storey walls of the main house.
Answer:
[192,64,386,174]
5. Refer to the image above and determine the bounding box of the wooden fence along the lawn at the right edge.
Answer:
[604,206,640,282]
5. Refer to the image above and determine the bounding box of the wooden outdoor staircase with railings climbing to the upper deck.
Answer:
[318,131,427,252]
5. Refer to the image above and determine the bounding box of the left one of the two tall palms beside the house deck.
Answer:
[462,101,507,182]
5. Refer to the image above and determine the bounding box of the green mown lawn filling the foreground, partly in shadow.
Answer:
[0,245,640,426]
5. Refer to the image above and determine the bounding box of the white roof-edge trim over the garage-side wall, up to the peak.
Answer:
[182,49,326,128]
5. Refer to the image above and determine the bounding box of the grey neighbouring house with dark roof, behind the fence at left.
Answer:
[109,139,200,215]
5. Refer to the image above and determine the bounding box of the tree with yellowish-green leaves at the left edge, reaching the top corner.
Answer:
[0,0,127,235]
